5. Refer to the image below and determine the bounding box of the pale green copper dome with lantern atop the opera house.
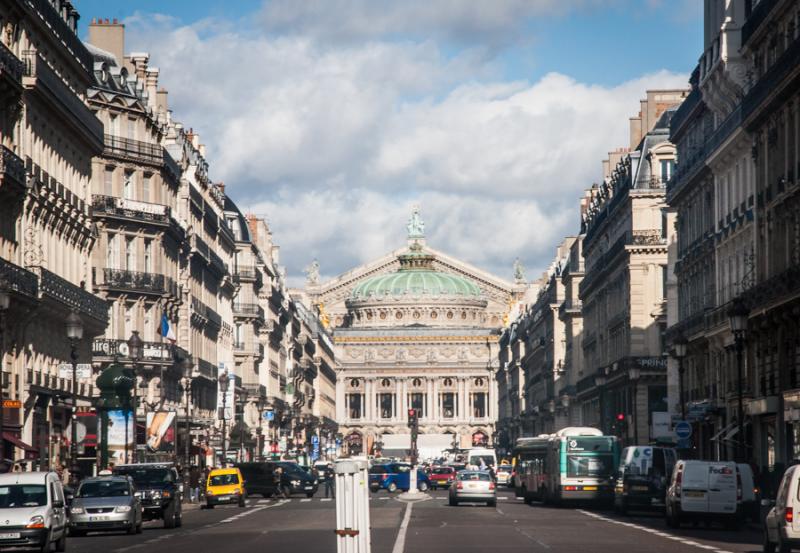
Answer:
[350,244,481,300]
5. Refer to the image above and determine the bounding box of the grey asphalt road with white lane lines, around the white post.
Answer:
[4,490,761,553]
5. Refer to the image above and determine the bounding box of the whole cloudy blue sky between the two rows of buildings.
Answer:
[75,0,702,284]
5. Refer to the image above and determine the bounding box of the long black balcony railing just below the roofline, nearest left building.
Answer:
[22,49,103,148]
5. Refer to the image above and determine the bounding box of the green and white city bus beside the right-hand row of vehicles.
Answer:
[515,427,620,504]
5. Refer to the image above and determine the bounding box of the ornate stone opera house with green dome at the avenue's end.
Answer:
[305,212,522,457]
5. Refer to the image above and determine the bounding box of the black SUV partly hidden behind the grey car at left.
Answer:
[114,463,183,528]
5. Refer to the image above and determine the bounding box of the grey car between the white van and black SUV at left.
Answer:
[69,476,142,536]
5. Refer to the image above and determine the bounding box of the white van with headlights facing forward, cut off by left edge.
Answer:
[0,472,67,551]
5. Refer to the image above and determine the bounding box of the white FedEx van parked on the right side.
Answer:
[666,461,742,530]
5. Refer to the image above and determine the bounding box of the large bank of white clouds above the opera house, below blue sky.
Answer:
[123,11,687,286]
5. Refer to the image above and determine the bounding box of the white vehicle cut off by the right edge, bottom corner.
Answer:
[764,465,800,553]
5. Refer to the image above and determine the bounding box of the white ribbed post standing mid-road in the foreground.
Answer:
[334,459,372,553]
